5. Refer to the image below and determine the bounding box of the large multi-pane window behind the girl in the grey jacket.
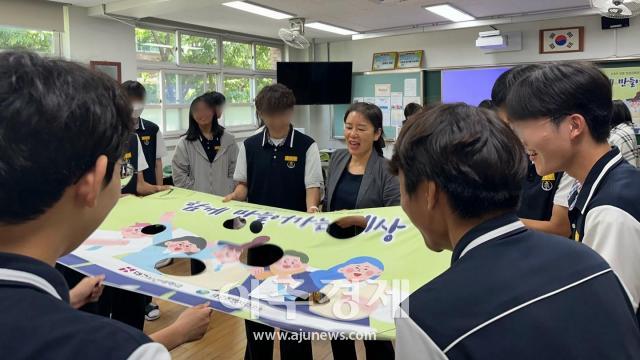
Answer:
[135,28,283,134]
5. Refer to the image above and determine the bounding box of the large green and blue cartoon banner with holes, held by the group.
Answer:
[59,188,451,339]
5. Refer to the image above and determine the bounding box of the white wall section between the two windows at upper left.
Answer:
[62,6,137,81]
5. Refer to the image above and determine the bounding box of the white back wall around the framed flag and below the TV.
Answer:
[309,16,640,148]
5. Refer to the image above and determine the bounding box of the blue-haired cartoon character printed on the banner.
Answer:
[309,256,388,321]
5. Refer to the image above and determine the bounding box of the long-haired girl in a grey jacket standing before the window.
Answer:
[171,92,238,196]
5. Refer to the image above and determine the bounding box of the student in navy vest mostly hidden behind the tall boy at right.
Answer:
[491,64,575,237]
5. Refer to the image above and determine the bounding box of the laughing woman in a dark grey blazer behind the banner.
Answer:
[324,103,400,360]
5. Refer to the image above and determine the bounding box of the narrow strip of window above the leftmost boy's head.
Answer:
[0,28,58,55]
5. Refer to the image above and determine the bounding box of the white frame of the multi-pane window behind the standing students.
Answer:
[136,26,285,138]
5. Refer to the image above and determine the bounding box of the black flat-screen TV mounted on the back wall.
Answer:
[278,62,353,105]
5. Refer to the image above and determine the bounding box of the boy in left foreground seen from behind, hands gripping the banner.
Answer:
[0,51,211,360]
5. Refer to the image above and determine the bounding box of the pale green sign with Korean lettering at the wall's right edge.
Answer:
[602,67,640,123]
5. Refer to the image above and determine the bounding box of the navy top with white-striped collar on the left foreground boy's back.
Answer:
[0,253,165,360]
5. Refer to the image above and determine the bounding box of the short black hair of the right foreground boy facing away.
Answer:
[390,103,527,219]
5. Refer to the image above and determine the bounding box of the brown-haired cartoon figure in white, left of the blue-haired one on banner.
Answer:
[249,250,309,302]
